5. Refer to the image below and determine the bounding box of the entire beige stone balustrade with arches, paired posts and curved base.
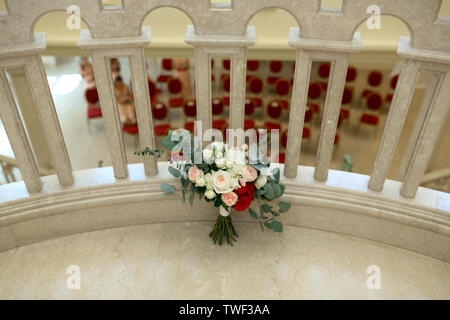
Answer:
[0,0,450,260]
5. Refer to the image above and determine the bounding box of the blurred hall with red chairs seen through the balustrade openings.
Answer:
[0,0,450,192]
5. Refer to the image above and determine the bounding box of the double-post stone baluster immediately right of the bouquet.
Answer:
[284,28,362,181]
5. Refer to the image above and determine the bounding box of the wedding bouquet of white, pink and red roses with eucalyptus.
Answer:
[136,130,291,245]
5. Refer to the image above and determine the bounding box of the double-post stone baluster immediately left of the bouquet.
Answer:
[78,27,158,179]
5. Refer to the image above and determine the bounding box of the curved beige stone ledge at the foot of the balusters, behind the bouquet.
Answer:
[0,162,450,261]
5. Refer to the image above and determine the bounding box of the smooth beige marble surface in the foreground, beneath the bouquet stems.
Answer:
[0,222,450,299]
